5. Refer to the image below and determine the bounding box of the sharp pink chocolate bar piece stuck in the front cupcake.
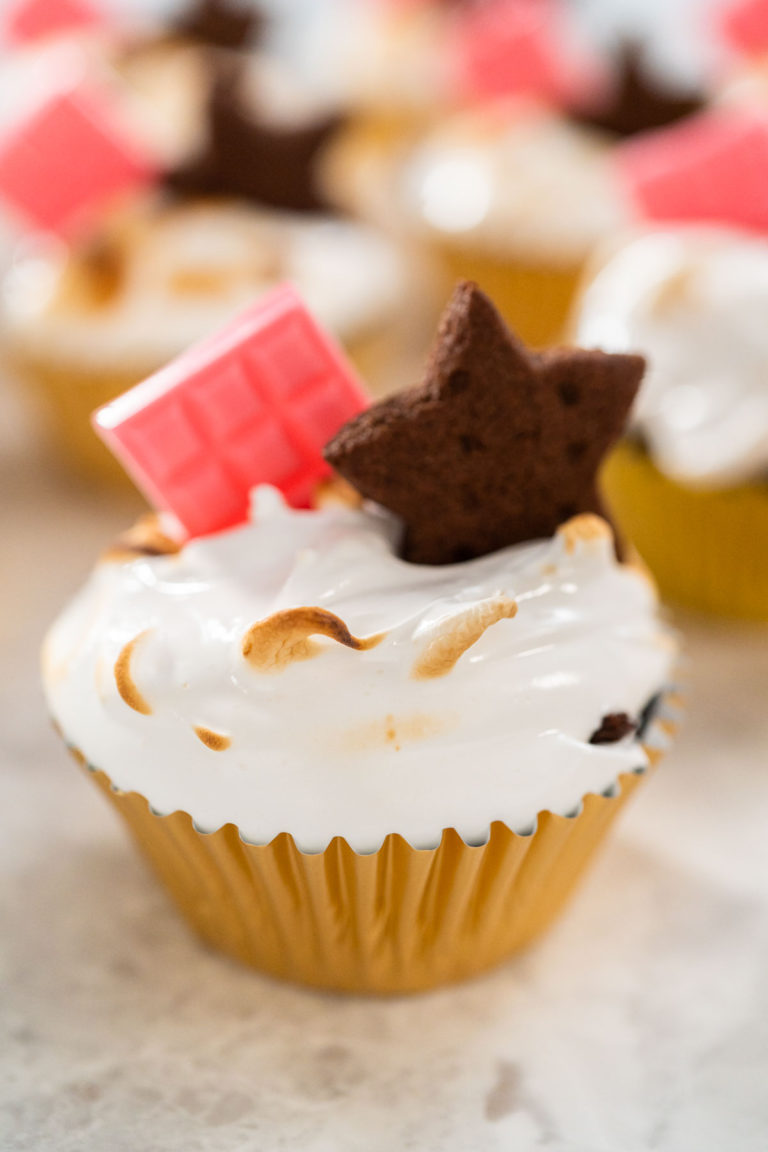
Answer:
[93,285,370,537]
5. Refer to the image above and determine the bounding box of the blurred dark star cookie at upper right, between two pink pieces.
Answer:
[571,40,706,137]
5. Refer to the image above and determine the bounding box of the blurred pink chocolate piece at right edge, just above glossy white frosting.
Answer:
[616,108,768,232]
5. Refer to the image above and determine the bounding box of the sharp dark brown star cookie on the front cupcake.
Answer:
[325,282,645,564]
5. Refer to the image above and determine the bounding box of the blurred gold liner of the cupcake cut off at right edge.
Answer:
[602,442,768,621]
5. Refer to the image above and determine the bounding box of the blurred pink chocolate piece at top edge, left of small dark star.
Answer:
[451,0,589,103]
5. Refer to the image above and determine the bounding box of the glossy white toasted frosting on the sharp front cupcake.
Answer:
[44,487,674,851]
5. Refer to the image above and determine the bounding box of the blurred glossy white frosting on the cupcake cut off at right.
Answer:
[575,228,768,487]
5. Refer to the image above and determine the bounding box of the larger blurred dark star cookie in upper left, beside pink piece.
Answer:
[166,69,341,212]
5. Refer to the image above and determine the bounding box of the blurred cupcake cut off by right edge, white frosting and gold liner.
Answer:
[573,226,768,620]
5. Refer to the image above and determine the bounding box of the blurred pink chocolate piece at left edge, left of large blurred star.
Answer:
[0,84,153,235]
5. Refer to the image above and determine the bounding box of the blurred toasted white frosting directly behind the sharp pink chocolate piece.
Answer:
[3,199,409,370]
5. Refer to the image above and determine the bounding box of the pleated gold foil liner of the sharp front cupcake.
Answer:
[63,697,674,993]
